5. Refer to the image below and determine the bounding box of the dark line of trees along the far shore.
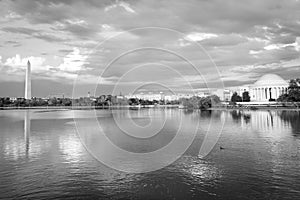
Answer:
[0,78,300,109]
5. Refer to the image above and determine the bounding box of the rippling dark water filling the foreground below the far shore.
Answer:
[0,109,300,199]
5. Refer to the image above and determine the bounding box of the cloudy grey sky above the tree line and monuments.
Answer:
[0,0,300,97]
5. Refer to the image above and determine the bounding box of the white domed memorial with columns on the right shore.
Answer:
[230,74,289,102]
